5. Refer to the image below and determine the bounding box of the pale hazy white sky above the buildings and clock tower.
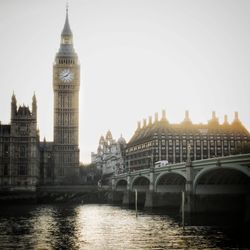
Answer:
[0,0,250,162]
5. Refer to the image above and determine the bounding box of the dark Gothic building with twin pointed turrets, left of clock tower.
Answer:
[0,94,40,190]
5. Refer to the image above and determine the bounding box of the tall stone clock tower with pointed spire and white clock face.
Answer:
[53,7,80,184]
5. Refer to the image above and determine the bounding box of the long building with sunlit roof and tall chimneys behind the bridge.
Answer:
[125,111,250,170]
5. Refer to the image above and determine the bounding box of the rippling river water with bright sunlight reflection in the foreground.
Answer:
[0,205,248,250]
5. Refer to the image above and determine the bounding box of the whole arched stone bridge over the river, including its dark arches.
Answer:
[112,154,250,218]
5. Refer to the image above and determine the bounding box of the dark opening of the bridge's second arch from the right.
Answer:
[155,171,186,193]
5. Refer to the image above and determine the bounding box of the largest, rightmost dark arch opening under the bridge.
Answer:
[193,166,250,194]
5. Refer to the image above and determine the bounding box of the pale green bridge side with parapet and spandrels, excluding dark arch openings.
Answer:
[113,154,250,192]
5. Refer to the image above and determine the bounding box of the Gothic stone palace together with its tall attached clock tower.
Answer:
[0,7,80,190]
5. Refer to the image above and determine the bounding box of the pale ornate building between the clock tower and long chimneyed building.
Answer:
[91,131,126,177]
